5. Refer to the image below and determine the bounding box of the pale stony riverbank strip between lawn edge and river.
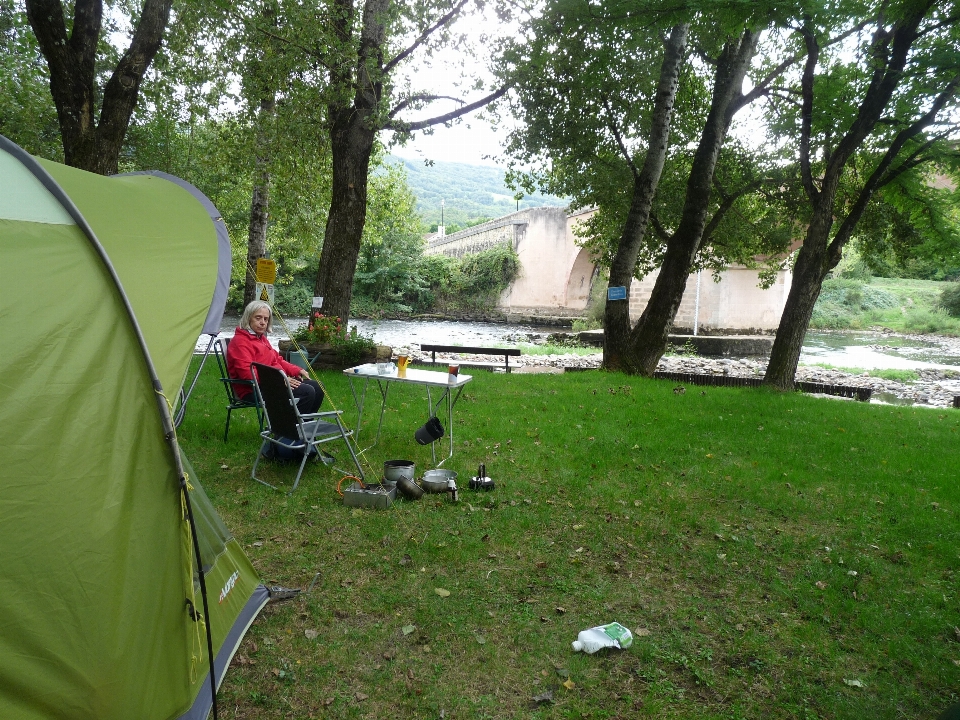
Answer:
[411,337,960,408]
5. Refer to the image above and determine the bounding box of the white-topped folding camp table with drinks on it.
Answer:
[343,363,473,467]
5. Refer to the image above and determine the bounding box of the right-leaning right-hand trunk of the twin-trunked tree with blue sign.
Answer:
[630,30,758,376]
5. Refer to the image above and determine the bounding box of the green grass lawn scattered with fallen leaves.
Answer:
[179,360,960,720]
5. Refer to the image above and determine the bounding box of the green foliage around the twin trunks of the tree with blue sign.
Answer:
[499,0,798,278]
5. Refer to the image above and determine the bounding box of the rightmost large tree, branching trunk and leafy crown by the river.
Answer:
[764,0,960,390]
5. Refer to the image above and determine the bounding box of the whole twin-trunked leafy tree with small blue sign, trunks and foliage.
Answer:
[503,0,790,374]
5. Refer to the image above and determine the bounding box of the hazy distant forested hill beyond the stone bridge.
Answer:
[388,155,566,229]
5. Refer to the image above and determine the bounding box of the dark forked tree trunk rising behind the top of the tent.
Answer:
[26,0,173,175]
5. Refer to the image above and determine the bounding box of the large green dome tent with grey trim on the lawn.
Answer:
[0,137,268,720]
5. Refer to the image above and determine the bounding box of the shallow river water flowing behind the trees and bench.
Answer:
[197,317,960,370]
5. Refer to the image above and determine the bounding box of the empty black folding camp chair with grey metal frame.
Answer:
[250,363,364,495]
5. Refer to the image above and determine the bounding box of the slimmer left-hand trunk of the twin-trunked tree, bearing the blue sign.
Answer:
[603,25,690,373]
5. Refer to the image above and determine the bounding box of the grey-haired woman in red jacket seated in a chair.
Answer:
[227,300,323,415]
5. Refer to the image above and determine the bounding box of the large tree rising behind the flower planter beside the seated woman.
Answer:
[314,0,506,320]
